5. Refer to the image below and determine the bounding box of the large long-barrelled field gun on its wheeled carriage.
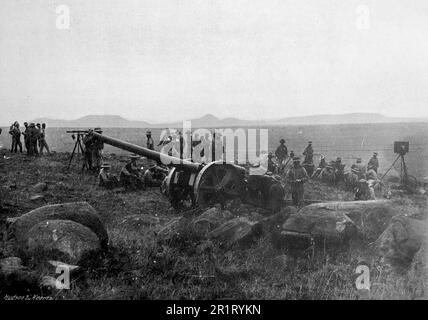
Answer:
[88,130,284,212]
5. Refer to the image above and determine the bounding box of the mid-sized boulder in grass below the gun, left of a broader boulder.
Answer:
[208,217,263,246]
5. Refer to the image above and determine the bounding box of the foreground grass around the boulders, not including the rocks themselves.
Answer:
[0,151,426,299]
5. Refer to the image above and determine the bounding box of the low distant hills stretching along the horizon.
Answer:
[27,113,428,128]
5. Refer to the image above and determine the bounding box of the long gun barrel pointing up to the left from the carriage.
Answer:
[89,131,202,172]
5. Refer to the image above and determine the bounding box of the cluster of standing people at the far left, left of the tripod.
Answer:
[9,121,50,155]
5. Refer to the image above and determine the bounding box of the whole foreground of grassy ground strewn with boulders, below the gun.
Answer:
[0,152,427,299]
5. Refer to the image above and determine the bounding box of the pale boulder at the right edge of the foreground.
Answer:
[374,215,427,268]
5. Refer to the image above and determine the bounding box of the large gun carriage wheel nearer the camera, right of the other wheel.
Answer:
[194,161,245,208]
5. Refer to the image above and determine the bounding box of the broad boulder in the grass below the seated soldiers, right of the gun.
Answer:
[274,205,358,248]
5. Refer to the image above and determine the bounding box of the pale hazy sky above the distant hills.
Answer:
[0,0,428,124]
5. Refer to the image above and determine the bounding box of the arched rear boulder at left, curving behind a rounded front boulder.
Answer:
[9,202,108,247]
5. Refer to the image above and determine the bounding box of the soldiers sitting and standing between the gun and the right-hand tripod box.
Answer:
[268,139,381,206]
